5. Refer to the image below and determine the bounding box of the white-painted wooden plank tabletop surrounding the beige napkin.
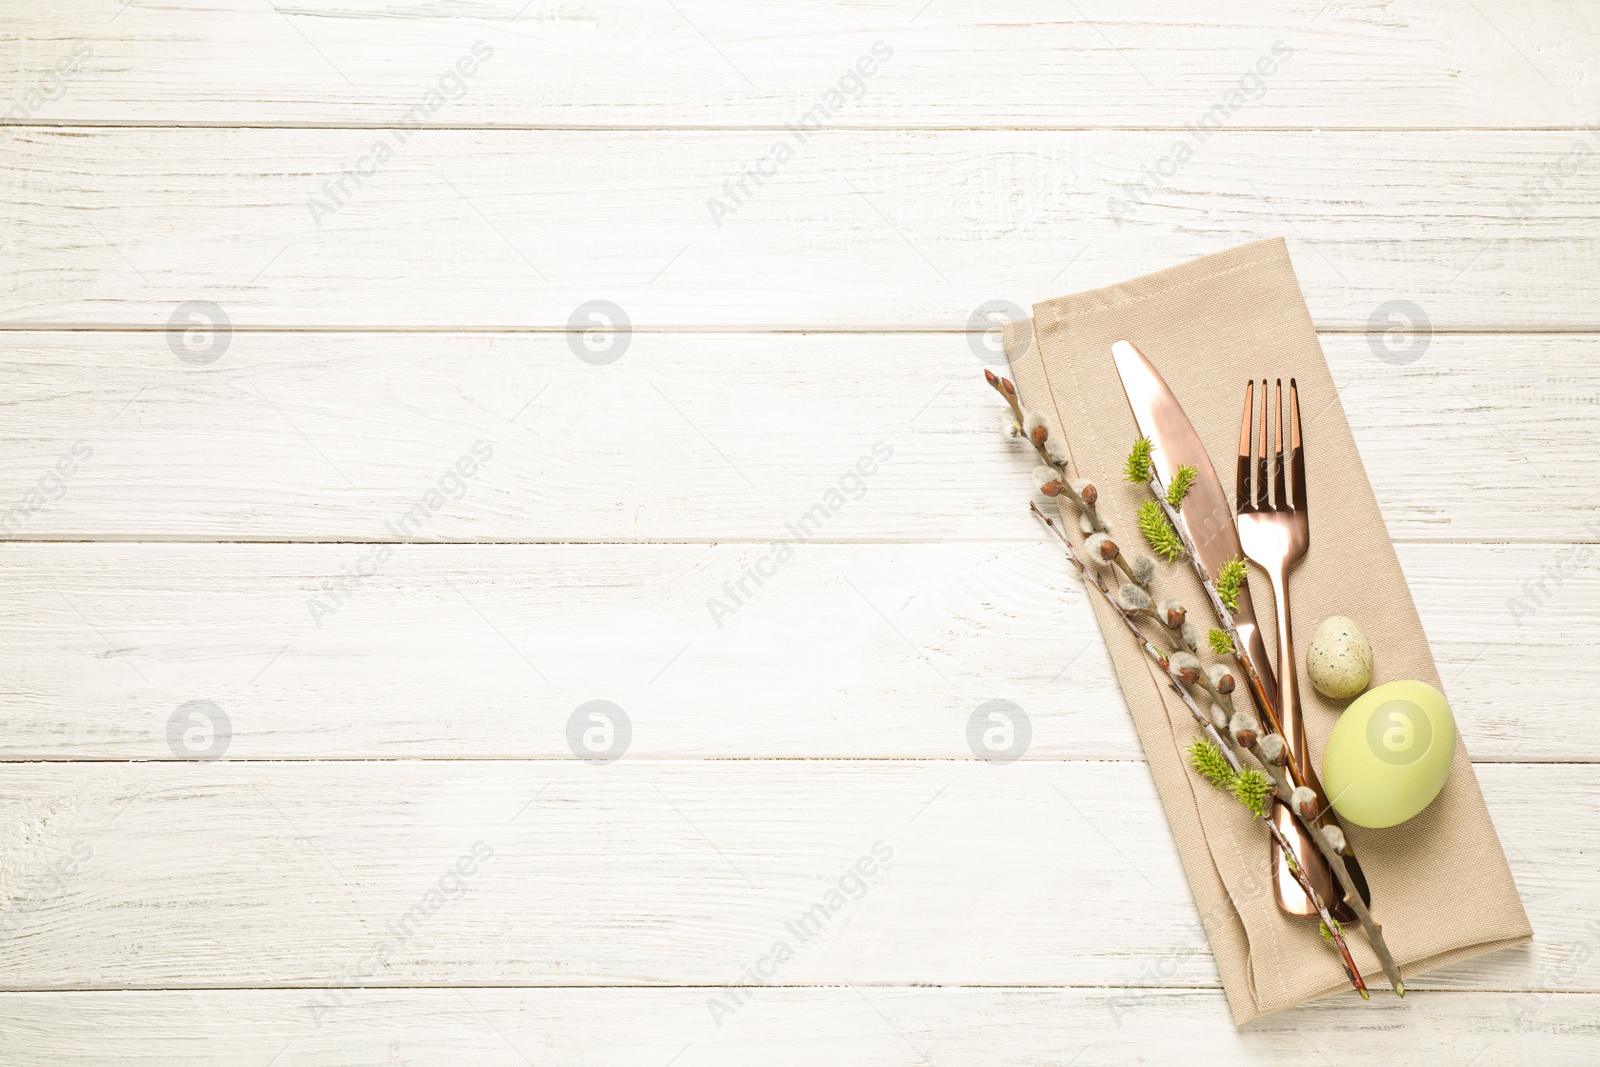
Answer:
[0,0,1600,1067]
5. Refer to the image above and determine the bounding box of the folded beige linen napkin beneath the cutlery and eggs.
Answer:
[1006,240,1533,1024]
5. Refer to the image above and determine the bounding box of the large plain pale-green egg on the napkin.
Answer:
[1322,681,1456,829]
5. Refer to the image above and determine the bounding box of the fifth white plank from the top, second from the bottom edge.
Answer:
[0,760,1580,1000]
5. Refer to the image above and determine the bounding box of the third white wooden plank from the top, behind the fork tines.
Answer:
[0,333,1600,542]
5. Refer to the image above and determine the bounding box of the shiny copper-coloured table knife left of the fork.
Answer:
[1110,341,1366,921]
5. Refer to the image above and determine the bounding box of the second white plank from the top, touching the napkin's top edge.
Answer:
[0,128,1600,331]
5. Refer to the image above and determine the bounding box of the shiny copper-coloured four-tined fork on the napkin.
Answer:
[1237,378,1370,921]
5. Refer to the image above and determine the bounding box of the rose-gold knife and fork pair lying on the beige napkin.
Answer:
[1112,341,1371,921]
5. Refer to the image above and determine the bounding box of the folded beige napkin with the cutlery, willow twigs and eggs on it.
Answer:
[974,240,1533,1025]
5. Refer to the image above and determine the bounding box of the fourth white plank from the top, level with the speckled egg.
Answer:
[0,542,1600,760]
